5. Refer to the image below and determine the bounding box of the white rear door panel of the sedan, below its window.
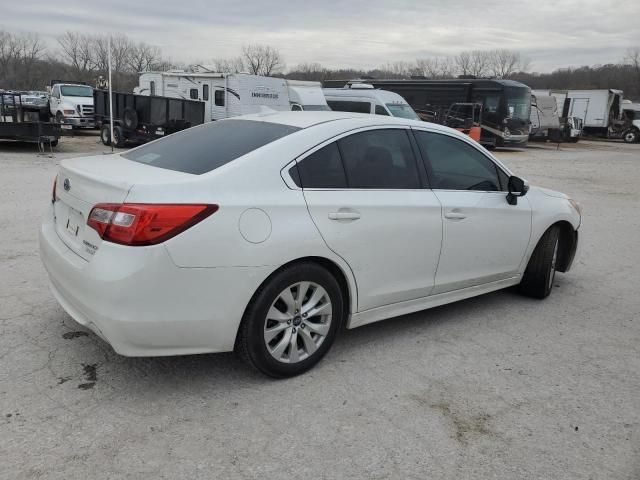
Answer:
[304,190,442,311]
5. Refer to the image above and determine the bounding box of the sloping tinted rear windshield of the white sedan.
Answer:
[122,120,300,175]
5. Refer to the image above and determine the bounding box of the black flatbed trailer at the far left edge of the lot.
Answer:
[0,91,61,147]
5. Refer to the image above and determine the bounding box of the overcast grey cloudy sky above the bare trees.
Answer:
[5,0,640,72]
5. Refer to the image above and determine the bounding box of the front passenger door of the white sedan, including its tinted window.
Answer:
[414,130,531,294]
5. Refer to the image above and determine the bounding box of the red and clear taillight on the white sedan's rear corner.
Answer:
[87,203,218,246]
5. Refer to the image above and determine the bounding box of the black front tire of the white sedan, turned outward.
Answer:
[519,225,560,299]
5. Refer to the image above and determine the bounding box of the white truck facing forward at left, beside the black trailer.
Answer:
[49,83,96,128]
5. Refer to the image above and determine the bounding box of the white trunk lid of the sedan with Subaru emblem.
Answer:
[53,155,191,261]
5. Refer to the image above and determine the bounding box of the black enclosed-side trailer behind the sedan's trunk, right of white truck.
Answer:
[93,90,204,147]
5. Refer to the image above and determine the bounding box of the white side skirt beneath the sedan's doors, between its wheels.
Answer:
[347,275,522,328]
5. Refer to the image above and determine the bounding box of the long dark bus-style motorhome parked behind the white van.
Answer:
[323,79,531,147]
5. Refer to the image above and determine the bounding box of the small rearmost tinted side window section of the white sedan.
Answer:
[292,142,347,188]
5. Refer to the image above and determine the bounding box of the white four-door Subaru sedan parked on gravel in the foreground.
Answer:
[40,112,580,377]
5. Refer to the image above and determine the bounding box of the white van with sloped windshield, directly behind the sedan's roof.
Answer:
[322,83,420,120]
